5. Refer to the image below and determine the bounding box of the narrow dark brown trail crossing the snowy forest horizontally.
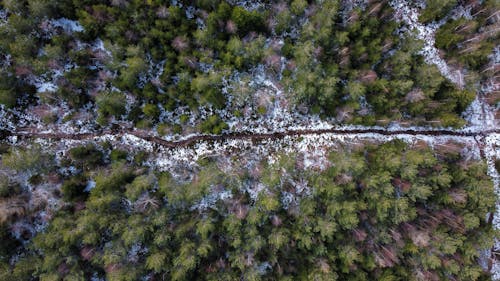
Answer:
[0,127,500,148]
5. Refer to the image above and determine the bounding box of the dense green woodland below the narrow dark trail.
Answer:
[0,141,495,280]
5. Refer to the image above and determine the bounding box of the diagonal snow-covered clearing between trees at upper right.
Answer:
[390,0,470,88]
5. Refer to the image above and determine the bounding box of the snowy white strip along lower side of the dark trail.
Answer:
[11,129,481,170]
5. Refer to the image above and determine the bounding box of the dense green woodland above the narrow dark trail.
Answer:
[0,0,498,131]
